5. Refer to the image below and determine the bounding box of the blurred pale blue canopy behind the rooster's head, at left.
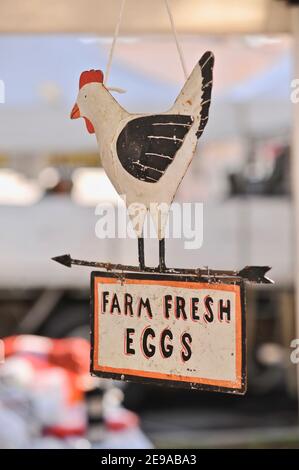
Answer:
[0,36,178,154]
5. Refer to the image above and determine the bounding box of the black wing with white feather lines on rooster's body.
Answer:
[116,114,193,183]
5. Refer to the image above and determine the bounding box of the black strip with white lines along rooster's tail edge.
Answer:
[196,51,214,139]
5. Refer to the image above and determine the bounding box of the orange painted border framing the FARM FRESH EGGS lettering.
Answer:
[91,271,246,393]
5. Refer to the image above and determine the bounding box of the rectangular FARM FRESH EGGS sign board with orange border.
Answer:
[92,272,246,393]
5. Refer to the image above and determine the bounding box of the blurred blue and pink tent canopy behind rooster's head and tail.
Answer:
[0,35,291,154]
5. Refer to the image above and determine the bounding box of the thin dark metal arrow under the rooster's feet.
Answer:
[52,255,274,284]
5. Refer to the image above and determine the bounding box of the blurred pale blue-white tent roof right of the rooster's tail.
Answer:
[206,53,292,140]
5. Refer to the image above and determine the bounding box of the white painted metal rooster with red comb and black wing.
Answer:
[71,52,214,271]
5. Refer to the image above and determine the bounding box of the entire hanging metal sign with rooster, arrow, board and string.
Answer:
[53,6,272,394]
